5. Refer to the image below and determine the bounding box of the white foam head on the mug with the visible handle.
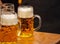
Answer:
[18,6,33,18]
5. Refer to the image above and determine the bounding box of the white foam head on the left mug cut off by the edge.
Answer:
[1,14,18,25]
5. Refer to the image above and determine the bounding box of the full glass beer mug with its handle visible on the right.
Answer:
[18,6,41,37]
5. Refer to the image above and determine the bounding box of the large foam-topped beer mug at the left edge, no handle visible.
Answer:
[0,3,18,44]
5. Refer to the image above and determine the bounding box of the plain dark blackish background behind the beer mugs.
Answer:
[2,0,60,34]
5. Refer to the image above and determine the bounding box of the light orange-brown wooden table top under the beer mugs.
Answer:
[18,32,60,44]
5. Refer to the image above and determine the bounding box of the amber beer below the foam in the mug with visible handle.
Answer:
[19,17,33,37]
